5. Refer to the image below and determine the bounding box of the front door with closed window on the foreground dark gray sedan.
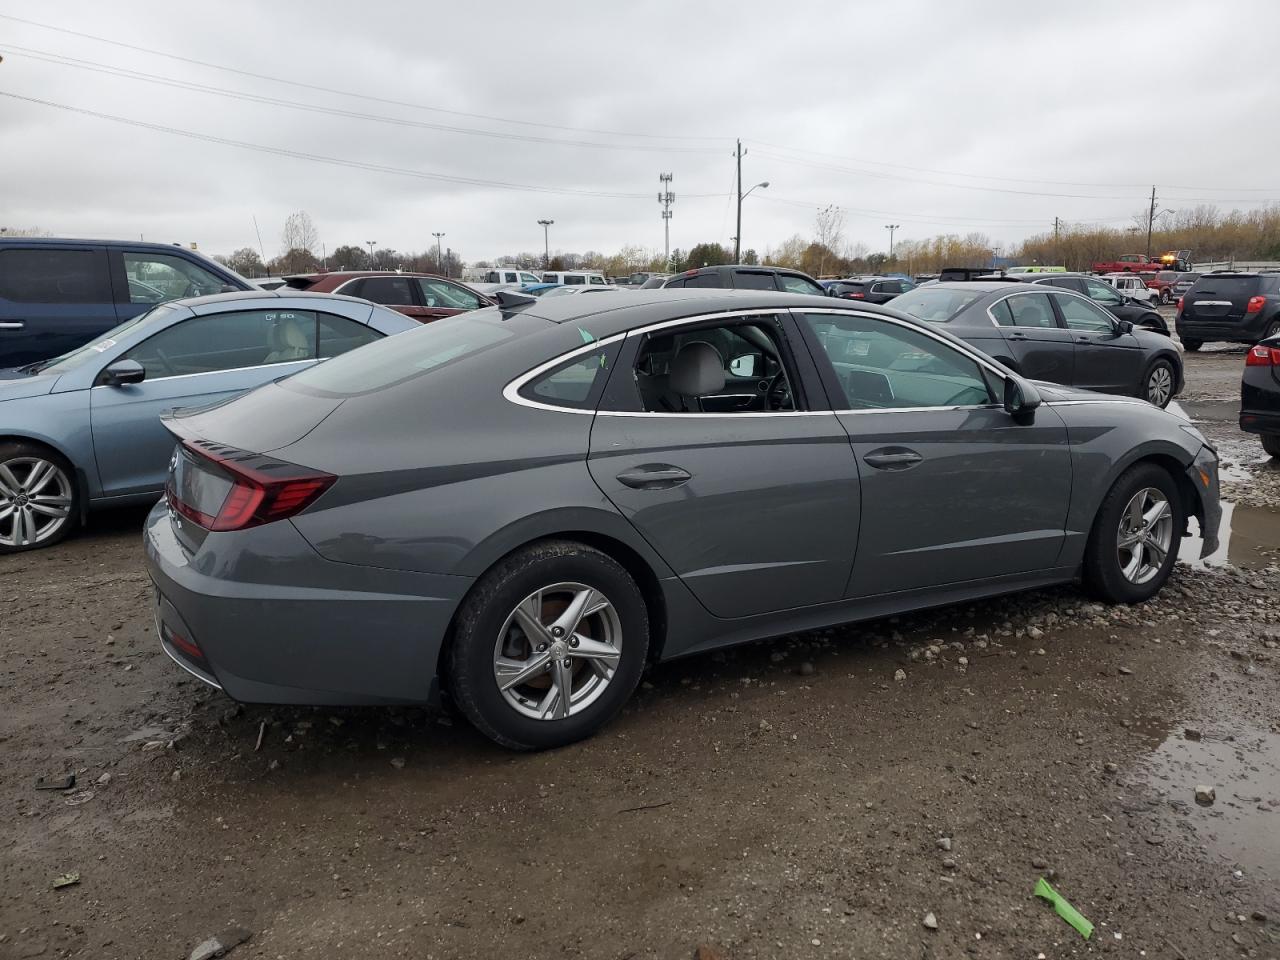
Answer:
[799,310,1071,598]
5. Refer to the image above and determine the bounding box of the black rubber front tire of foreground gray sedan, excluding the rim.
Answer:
[1084,463,1184,603]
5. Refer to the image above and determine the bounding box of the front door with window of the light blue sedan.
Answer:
[90,308,316,497]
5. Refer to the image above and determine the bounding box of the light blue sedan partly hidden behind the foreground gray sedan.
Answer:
[0,291,421,553]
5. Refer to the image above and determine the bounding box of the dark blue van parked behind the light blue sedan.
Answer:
[0,237,253,367]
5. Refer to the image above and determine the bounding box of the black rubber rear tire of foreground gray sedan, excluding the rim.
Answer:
[445,540,649,750]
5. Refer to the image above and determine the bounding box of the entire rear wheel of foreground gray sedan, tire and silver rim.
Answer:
[447,540,649,750]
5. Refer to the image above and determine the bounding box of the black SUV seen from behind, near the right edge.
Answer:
[1174,270,1280,349]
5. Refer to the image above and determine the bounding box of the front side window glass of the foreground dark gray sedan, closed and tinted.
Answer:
[801,314,992,410]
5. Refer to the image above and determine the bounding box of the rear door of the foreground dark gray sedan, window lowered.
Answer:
[588,312,859,618]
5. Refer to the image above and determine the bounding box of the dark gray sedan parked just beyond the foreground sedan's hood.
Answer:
[893,280,1183,407]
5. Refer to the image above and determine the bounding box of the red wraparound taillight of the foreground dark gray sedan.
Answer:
[165,440,338,532]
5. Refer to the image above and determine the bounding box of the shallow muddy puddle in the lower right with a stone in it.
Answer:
[1140,727,1280,882]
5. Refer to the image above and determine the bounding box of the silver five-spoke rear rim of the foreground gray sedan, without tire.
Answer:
[493,582,622,721]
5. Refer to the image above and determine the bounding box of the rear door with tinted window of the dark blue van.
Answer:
[0,243,118,367]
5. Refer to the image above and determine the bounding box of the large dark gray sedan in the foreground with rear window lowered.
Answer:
[146,291,1220,749]
